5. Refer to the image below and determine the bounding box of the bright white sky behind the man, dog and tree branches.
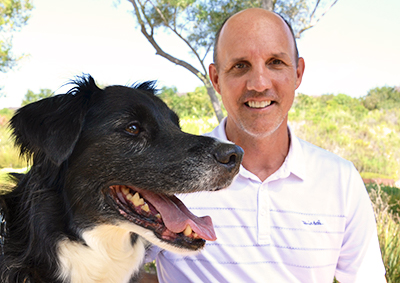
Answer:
[0,0,400,109]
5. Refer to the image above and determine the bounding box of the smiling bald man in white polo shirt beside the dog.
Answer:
[142,9,385,283]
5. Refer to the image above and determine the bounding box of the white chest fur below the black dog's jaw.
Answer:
[58,225,145,283]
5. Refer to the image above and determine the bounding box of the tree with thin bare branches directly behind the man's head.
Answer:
[127,0,338,121]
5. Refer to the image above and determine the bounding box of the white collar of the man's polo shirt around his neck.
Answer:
[206,117,306,182]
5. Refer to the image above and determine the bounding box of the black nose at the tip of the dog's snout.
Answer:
[214,143,243,170]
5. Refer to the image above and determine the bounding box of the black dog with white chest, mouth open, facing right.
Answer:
[0,75,243,283]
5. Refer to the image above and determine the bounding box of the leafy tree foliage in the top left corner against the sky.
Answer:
[0,0,33,73]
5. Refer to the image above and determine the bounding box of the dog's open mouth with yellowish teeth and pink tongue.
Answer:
[109,185,217,250]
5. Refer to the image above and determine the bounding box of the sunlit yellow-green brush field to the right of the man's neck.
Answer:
[289,91,400,179]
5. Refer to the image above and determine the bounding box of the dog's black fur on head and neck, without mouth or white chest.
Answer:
[0,76,243,282]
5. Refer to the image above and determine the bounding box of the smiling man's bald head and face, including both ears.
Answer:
[210,10,304,138]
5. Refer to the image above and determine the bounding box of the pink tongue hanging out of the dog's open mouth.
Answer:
[140,191,217,241]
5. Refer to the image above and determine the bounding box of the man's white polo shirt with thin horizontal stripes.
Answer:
[149,121,385,283]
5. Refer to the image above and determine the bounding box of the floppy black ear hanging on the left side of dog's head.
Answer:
[10,76,102,166]
